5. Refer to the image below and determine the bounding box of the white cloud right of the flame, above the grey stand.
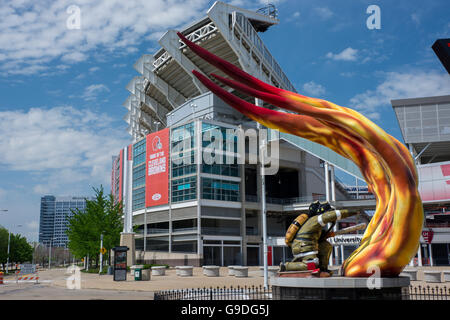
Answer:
[350,70,450,119]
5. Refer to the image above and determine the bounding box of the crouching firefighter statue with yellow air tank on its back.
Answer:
[280,201,359,277]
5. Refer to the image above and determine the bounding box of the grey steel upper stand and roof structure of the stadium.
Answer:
[123,1,362,179]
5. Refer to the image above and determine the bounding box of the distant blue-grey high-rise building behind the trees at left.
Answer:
[39,195,92,247]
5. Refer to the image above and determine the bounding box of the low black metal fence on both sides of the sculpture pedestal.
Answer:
[154,286,450,300]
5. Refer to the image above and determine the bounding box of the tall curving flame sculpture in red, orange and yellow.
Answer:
[178,33,423,277]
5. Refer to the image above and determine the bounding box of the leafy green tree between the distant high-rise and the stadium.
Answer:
[67,186,123,266]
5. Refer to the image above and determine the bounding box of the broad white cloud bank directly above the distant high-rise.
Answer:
[0,106,129,194]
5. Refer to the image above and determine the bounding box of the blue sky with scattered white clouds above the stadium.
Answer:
[0,0,450,240]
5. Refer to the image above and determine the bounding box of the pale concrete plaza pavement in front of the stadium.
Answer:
[0,267,450,300]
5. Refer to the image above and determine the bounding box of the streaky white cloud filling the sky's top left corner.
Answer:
[0,0,209,75]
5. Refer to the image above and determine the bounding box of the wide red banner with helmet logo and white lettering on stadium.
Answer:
[145,128,169,207]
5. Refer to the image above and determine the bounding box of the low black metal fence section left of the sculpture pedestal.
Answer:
[154,286,272,300]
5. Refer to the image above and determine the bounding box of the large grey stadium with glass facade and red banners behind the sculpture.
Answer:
[111,1,450,266]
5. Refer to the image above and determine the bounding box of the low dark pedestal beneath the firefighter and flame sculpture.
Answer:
[270,272,410,300]
